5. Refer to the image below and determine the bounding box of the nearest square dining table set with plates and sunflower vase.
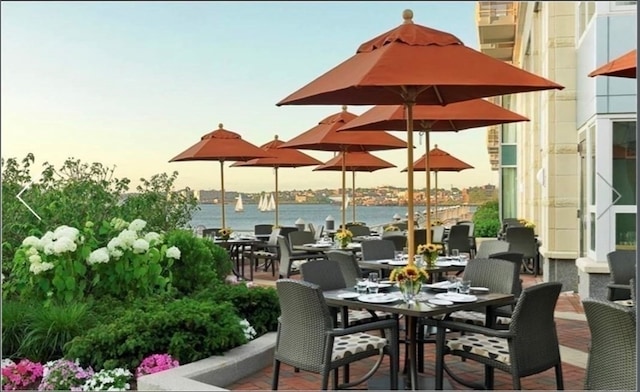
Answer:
[323,289,514,390]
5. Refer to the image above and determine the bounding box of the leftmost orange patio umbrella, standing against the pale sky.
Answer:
[169,124,271,228]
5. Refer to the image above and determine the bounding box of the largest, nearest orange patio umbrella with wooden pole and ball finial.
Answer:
[277,10,563,266]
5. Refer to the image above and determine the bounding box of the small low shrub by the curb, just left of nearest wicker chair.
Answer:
[196,283,280,336]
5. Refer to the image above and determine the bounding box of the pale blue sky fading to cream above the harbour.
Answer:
[1,1,497,192]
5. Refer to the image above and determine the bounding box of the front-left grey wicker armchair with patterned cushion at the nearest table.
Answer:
[271,279,399,390]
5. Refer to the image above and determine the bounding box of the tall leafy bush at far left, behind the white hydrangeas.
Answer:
[1,154,198,275]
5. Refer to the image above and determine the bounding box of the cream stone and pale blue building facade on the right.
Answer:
[477,1,637,298]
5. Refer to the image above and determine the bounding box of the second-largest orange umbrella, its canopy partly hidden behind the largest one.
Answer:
[339,99,529,230]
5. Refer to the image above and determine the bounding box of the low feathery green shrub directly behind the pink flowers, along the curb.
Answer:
[64,298,246,370]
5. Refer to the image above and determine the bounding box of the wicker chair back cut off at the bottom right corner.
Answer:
[582,298,637,391]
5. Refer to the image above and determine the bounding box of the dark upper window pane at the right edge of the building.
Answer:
[611,121,636,206]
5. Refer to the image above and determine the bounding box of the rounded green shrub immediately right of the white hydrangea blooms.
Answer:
[165,230,233,295]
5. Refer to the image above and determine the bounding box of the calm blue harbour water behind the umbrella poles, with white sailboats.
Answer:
[190,204,410,231]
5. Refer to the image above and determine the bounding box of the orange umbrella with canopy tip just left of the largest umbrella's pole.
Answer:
[278,106,407,227]
